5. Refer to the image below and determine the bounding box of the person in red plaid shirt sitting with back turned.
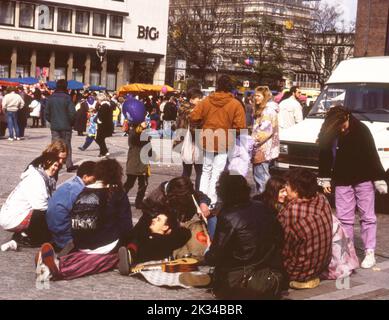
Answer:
[278,169,332,289]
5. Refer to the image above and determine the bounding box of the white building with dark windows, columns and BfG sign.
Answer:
[0,0,169,90]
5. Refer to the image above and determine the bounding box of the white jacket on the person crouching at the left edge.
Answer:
[0,166,49,230]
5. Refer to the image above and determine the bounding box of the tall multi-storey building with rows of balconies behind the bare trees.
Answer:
[168,0,312,89]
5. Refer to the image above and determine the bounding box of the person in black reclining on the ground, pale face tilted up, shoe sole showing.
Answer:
[118,197,191,275]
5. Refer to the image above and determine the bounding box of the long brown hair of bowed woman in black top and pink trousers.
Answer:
[317,105,351,147]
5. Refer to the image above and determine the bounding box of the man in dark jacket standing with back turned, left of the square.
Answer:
[45,79,77,172]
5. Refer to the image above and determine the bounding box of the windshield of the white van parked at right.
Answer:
[308,83,389,122]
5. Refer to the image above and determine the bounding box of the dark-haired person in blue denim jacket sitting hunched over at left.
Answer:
[46,161,96,250]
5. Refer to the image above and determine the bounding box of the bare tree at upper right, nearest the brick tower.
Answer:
[299,3,355,88]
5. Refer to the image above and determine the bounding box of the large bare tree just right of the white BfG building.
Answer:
[168,0,230,83]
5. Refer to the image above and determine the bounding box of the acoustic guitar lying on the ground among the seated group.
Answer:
[130,258,198,274]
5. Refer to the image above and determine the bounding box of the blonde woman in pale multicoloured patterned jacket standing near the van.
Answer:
[252,86,280,193]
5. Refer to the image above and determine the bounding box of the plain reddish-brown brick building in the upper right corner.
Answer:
[355,0,389,57]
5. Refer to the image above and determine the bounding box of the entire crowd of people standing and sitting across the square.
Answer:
[0,76,387,299]
